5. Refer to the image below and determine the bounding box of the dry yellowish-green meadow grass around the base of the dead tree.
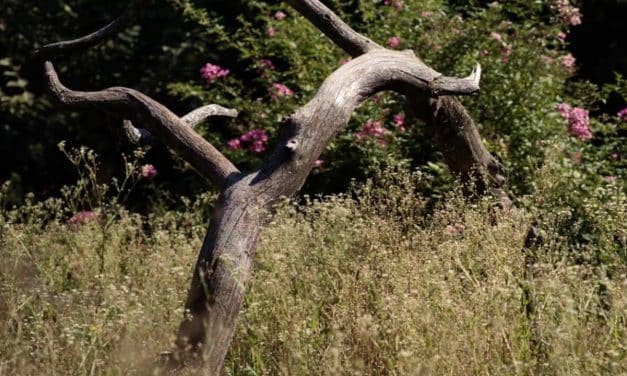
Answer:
[0,172,627,375]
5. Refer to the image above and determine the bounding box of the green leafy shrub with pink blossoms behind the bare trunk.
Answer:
[0,0,627,206]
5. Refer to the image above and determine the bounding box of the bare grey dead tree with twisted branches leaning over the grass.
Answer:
[36,0,505,375]
